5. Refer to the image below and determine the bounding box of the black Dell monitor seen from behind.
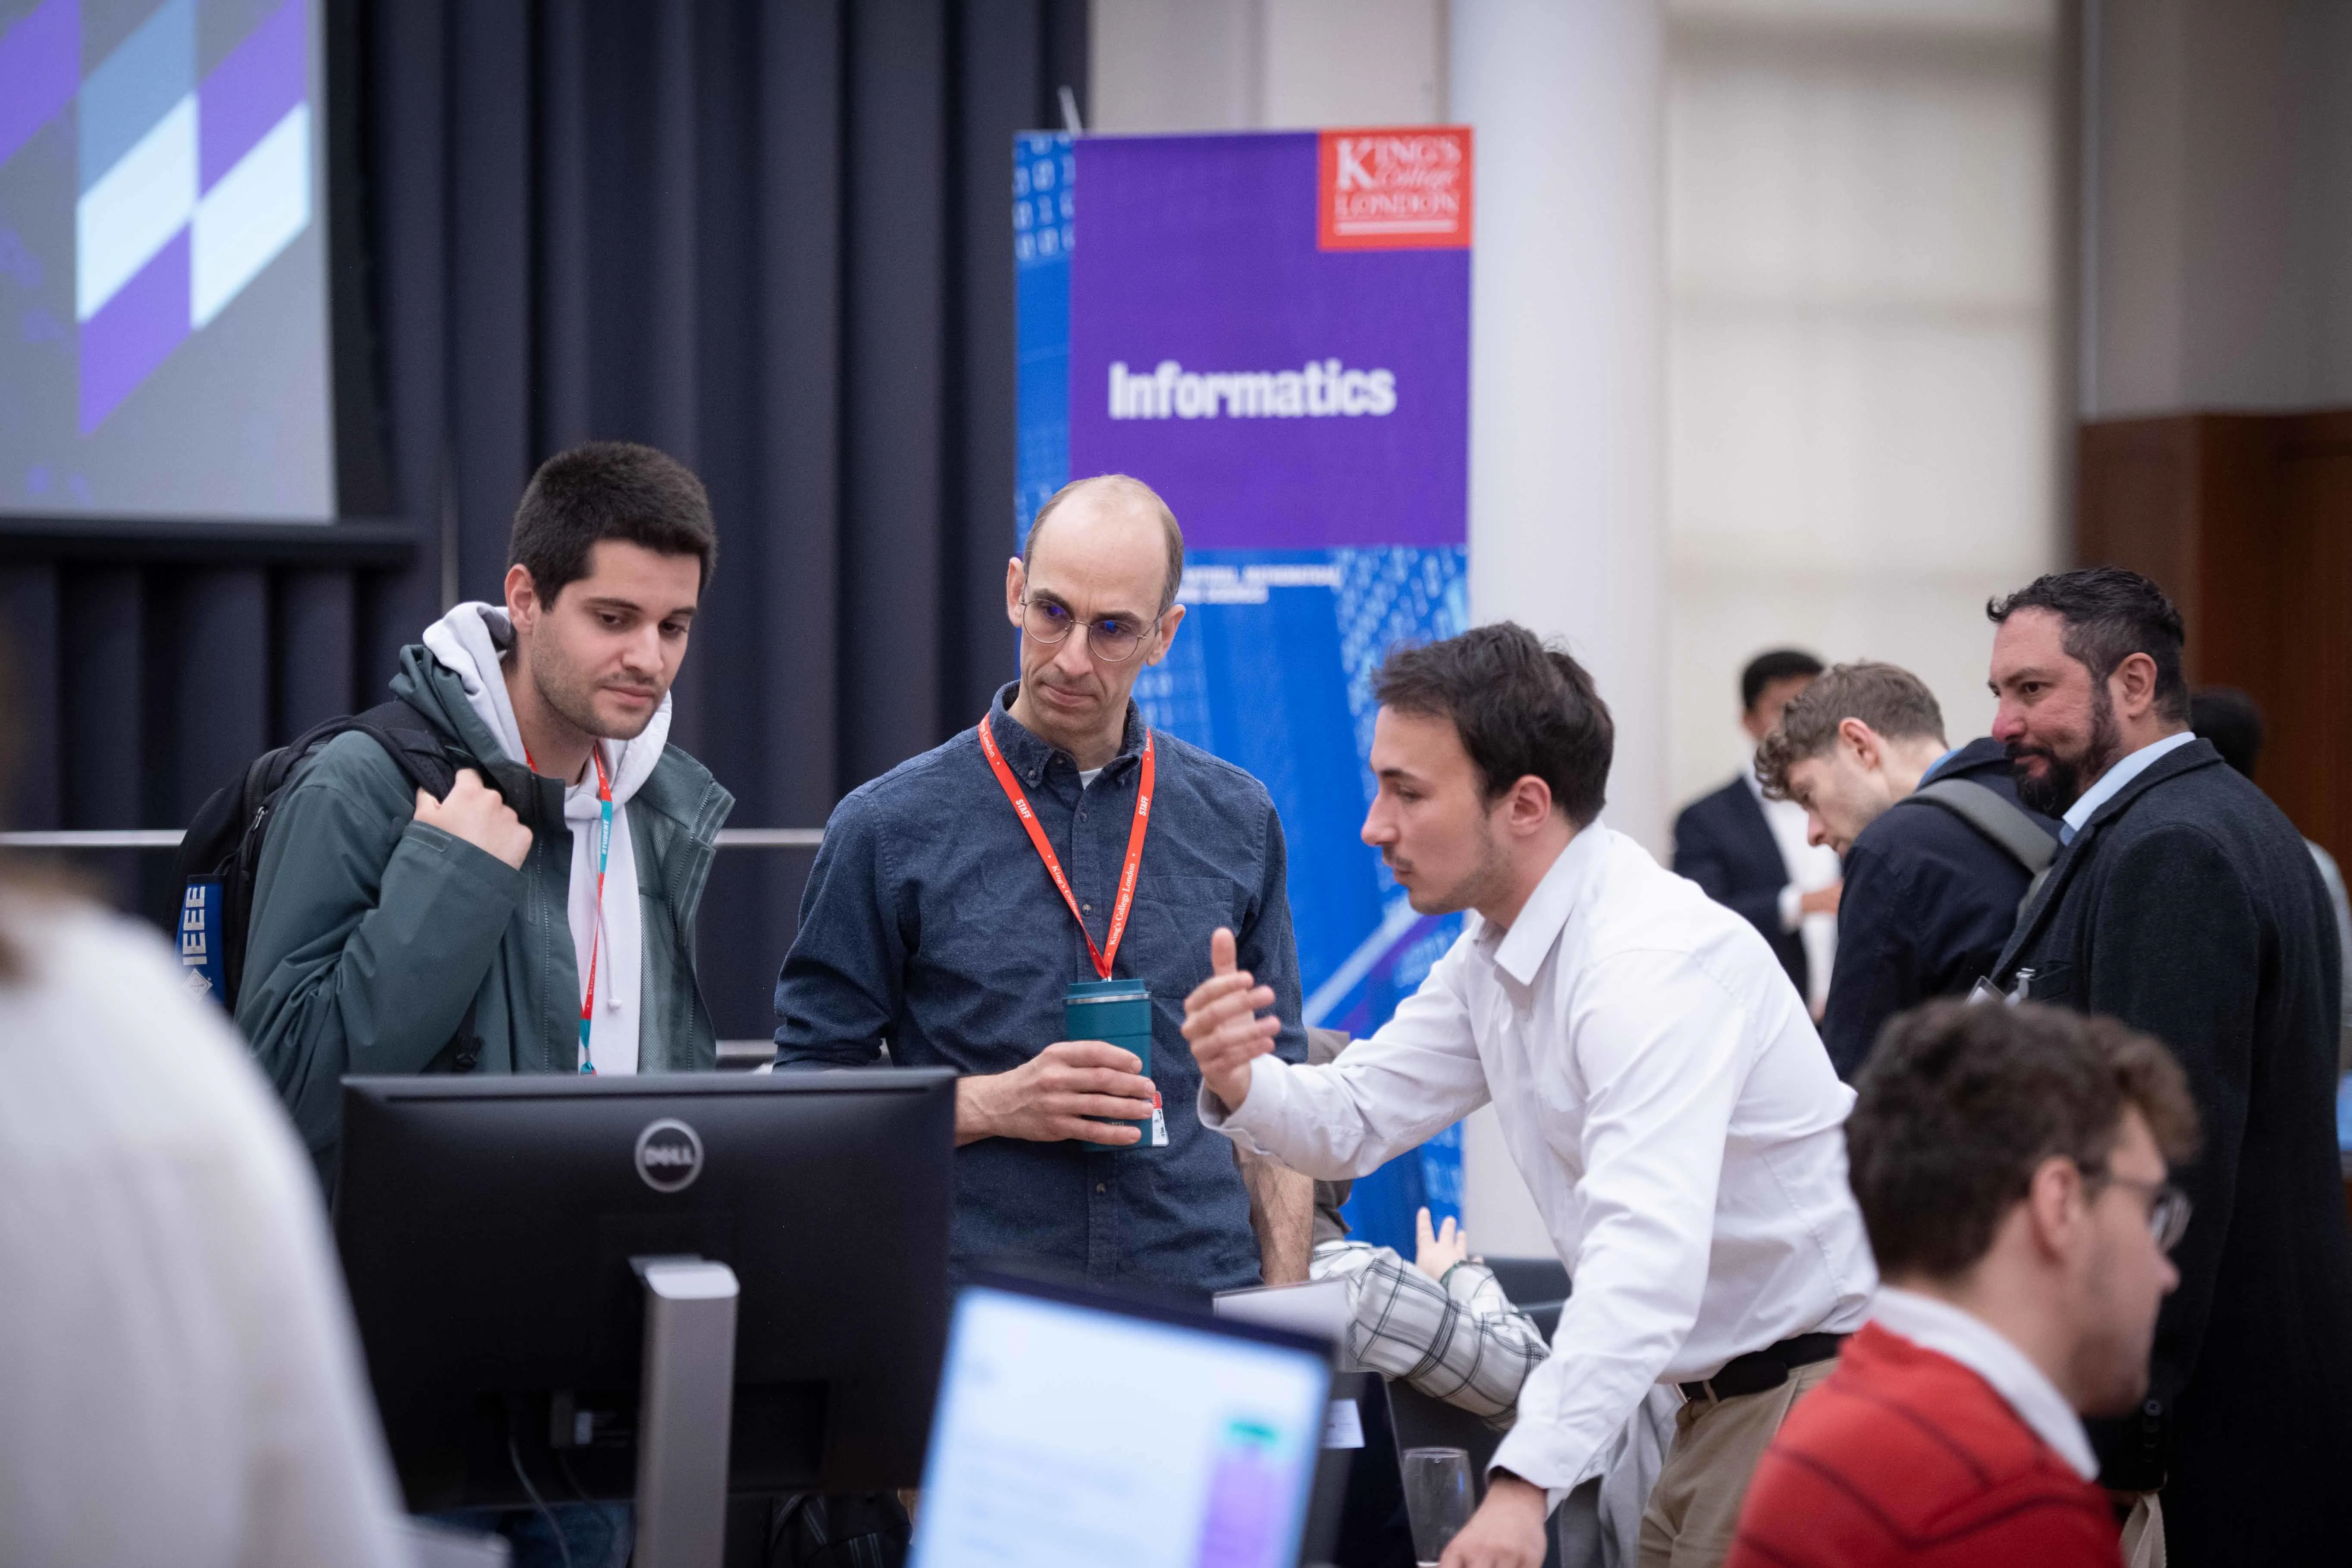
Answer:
[334,1067,955,1514]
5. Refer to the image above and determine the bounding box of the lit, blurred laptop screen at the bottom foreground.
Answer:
[913,1286,1331,1568]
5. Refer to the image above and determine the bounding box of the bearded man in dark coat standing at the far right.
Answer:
[1988,567,2352,1568]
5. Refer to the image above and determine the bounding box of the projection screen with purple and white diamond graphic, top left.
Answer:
[0,0,334,515]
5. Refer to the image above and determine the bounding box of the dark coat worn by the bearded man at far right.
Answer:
[1994,740,2352,1568]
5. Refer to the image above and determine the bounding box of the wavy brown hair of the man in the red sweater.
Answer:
[1846,1001,2197,1279]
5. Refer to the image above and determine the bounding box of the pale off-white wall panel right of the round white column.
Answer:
[1665,0,2067,802]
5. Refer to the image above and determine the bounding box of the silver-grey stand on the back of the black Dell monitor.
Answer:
[628,1258,736,1568]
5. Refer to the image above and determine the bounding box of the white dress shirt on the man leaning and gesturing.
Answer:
[1202,823,1877,1502]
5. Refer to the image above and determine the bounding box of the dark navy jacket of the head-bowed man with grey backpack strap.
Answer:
[1820,738,2058,1082]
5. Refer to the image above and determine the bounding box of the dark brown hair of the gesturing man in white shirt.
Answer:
[1374,621,1616,828]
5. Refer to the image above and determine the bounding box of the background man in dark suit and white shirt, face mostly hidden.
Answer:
[1675,649,1841,1018]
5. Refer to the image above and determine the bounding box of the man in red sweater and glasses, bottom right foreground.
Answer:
[1726,1001,2197,1568]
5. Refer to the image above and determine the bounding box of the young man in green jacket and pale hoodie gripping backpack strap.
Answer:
[238,442,734,1182]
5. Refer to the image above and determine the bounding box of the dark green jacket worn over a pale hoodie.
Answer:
[238,644,734,1187]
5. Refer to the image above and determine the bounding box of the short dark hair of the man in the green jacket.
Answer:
[506,442,720,604]
